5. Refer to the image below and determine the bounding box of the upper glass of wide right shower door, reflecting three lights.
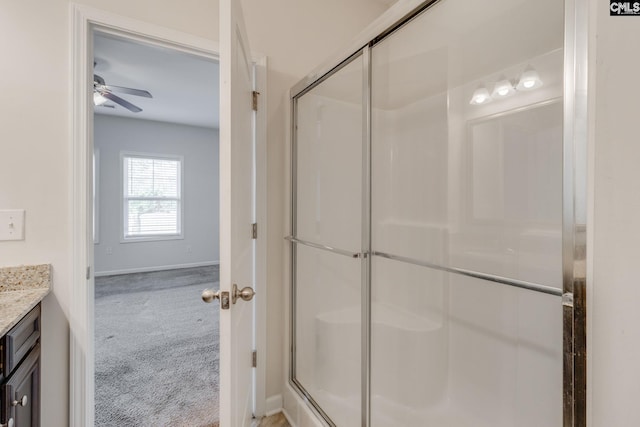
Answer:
[372,0,564,288]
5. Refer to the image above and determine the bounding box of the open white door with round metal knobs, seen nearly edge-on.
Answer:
[220,0,256,427]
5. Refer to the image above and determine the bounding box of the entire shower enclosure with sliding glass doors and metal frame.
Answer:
[288,0,584,427]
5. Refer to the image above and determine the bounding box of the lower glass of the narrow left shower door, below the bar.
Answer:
[295,245,362,426]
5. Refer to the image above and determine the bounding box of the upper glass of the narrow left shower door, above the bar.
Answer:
[295,55,363,253]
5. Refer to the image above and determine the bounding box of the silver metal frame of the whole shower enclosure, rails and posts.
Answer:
[287,0,588,427]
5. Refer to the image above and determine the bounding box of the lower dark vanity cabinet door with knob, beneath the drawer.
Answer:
[2,344,40,427]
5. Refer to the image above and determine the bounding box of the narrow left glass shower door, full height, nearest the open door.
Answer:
[292,53,364,426]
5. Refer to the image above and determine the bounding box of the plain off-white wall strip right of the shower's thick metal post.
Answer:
[587,0,640,427]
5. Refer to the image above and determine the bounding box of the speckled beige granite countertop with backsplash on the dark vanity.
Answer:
[0,264,51,336]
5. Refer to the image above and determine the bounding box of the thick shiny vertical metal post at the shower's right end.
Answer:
[562,0,589,427]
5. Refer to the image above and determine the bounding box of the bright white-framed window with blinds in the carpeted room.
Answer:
[122,154,182,241]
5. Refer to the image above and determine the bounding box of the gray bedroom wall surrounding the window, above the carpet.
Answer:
[94,114,220,275]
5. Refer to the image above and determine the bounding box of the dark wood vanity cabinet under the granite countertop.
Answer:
[0,305,40,427]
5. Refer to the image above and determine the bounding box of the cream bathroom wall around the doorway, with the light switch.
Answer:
[0,0,385,427]
